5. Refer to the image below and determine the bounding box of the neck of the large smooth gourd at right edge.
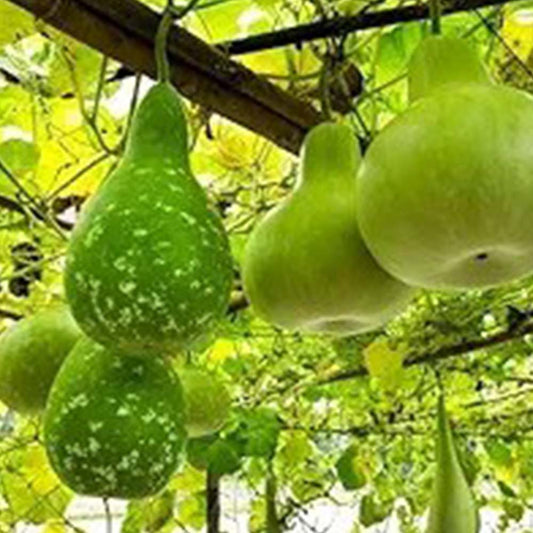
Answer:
[408,35,492,102]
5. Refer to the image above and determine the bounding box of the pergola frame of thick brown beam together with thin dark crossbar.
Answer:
[4,0,512,153]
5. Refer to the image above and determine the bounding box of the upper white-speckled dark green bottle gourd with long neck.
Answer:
[65,82,232,353]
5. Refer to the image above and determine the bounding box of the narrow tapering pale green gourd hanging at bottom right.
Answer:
[426,396,479,533]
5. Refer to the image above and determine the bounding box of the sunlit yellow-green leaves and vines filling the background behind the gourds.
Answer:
[0,0,533,533]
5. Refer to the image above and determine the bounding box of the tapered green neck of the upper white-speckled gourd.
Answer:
[124,82,189,167]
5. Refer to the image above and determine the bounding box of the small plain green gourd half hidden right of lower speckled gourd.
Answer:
[178,367,231,439]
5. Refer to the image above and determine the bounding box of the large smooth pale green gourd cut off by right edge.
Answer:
[358,37,533,289]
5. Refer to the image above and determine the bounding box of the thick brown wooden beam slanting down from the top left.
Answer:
[10,0,321,153]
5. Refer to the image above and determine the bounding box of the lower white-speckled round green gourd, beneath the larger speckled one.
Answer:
[44,338,186,499]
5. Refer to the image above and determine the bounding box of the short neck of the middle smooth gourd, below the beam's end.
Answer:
[297,122,361,188]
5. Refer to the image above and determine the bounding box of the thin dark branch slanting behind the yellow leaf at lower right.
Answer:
[324,322,533,385]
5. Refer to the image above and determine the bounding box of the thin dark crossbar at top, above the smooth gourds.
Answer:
[222,0,517,55]
